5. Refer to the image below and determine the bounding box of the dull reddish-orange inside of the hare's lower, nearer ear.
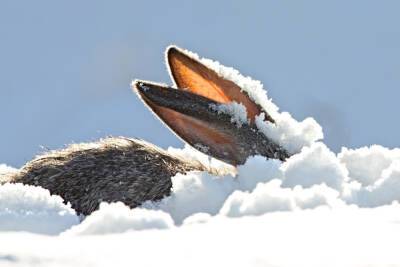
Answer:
[142,94,239,165]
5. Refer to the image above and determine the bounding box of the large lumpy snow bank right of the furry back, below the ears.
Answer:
[143,142,400,225]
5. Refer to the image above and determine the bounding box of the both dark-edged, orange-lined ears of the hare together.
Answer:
[133,46,288,165]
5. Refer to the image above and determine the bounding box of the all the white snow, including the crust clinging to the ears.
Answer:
[0,47,400,266]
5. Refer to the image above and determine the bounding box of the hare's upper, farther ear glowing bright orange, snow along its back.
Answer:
[166,46,273,123]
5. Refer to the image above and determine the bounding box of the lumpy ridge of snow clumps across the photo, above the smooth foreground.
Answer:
[0,137,400,240]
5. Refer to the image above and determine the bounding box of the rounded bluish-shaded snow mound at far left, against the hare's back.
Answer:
[0,184,79,234]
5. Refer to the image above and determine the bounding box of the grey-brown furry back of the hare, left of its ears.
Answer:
[4,137,205,215]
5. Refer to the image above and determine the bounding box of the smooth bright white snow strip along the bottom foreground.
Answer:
[0,207,400,267]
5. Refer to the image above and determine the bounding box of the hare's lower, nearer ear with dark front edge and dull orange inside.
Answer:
[133,81,246,165]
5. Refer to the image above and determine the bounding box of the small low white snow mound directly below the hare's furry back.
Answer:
[64,202,174,235]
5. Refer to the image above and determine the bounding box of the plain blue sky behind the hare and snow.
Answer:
[0,0,400,167]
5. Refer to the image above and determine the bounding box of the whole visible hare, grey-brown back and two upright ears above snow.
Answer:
[3,46,289,215]
